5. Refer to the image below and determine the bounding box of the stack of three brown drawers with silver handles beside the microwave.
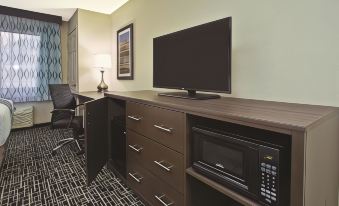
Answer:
[126,101,185,206]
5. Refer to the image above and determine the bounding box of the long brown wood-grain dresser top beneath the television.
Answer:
[104,90,339,131]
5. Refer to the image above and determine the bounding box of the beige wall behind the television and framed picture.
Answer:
[110,0,339,106]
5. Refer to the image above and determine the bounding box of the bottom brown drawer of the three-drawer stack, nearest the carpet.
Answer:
[127,159,184,206]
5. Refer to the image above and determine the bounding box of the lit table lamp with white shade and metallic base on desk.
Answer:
[94,54,111,92]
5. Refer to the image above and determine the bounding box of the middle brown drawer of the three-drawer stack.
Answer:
[126,130,184,193]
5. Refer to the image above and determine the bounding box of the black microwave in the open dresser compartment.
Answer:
[191,127,290,206]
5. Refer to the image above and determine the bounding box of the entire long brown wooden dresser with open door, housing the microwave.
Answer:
[79,91,339,206]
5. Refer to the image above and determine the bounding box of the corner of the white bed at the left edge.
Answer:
[0,98,14,168]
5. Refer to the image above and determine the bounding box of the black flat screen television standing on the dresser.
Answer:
[153,17,232,99]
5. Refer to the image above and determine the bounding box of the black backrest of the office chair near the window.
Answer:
[48,84,76,109]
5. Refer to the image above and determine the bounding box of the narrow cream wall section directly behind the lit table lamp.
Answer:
[78,9,112,91]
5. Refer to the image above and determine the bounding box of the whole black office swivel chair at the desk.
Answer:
[48,84,84,155]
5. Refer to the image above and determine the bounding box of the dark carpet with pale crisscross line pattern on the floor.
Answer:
[0,127,143,206]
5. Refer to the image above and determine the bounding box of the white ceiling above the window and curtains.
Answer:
[0,0,128,21]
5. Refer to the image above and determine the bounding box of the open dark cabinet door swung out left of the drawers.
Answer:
[84,98,109,184]
